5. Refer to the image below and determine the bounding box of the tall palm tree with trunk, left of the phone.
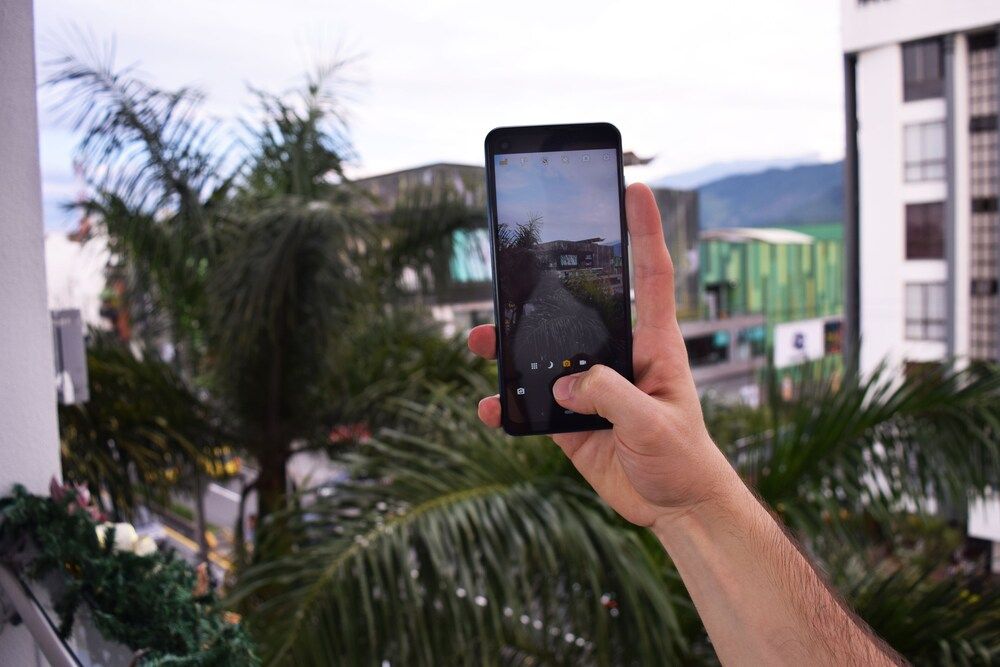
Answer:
[51,51,482,532]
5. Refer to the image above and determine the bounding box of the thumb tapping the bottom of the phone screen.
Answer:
[552,365,656,430]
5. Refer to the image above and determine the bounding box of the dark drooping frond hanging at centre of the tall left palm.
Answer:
[208,197,374,436]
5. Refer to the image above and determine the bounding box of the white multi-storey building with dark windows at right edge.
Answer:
[841,0,1000,558]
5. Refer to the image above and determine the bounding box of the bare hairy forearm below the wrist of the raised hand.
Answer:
[653,464,898,665]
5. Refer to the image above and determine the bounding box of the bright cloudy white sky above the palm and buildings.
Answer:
[35,0,843,229]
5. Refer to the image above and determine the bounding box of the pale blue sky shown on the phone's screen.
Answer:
[495,150,621,243]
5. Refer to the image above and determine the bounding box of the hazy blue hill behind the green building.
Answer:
[698,162,844,229]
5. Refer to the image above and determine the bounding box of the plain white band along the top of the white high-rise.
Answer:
[840,0,1000,53]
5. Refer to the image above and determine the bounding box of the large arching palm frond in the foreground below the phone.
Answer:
[233,395,686,664]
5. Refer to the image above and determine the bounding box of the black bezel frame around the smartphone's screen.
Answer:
[485,123,634,435]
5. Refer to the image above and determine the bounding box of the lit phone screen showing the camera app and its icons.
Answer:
[494,149,629,424]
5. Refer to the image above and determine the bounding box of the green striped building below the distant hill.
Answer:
[699,223,844,347]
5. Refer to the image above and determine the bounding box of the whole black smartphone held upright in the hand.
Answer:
[486,123,633,435]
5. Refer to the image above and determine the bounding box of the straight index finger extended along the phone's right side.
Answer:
[625,183,676,327]
